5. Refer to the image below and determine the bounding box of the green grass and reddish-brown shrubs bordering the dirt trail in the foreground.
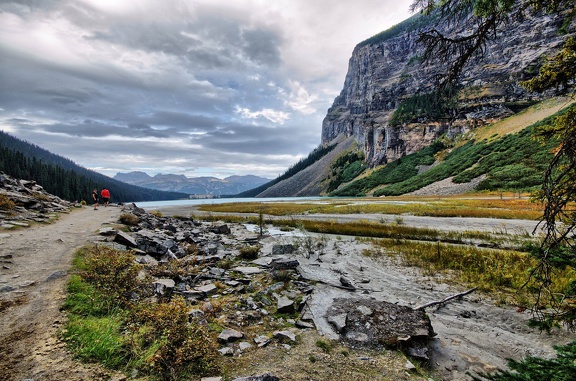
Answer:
[62,246,219,380]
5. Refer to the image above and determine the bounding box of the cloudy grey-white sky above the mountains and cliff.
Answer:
[0,0,412,178]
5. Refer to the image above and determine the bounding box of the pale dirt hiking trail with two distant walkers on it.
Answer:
[0,206,121,381]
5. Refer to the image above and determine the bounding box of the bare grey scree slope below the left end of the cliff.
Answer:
[257,136,356,197]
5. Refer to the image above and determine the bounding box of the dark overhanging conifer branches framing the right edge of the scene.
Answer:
[412,0,576,381]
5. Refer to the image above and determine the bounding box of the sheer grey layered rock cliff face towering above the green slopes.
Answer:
[322,9,574,166]
